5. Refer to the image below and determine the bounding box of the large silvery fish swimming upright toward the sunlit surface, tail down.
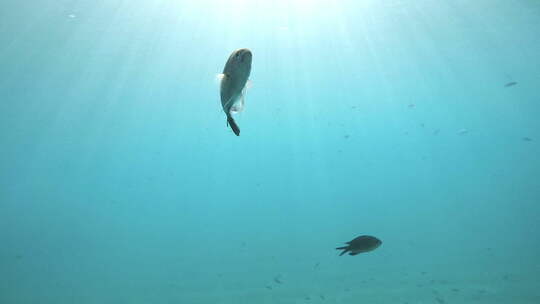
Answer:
[219,49,253,136]
